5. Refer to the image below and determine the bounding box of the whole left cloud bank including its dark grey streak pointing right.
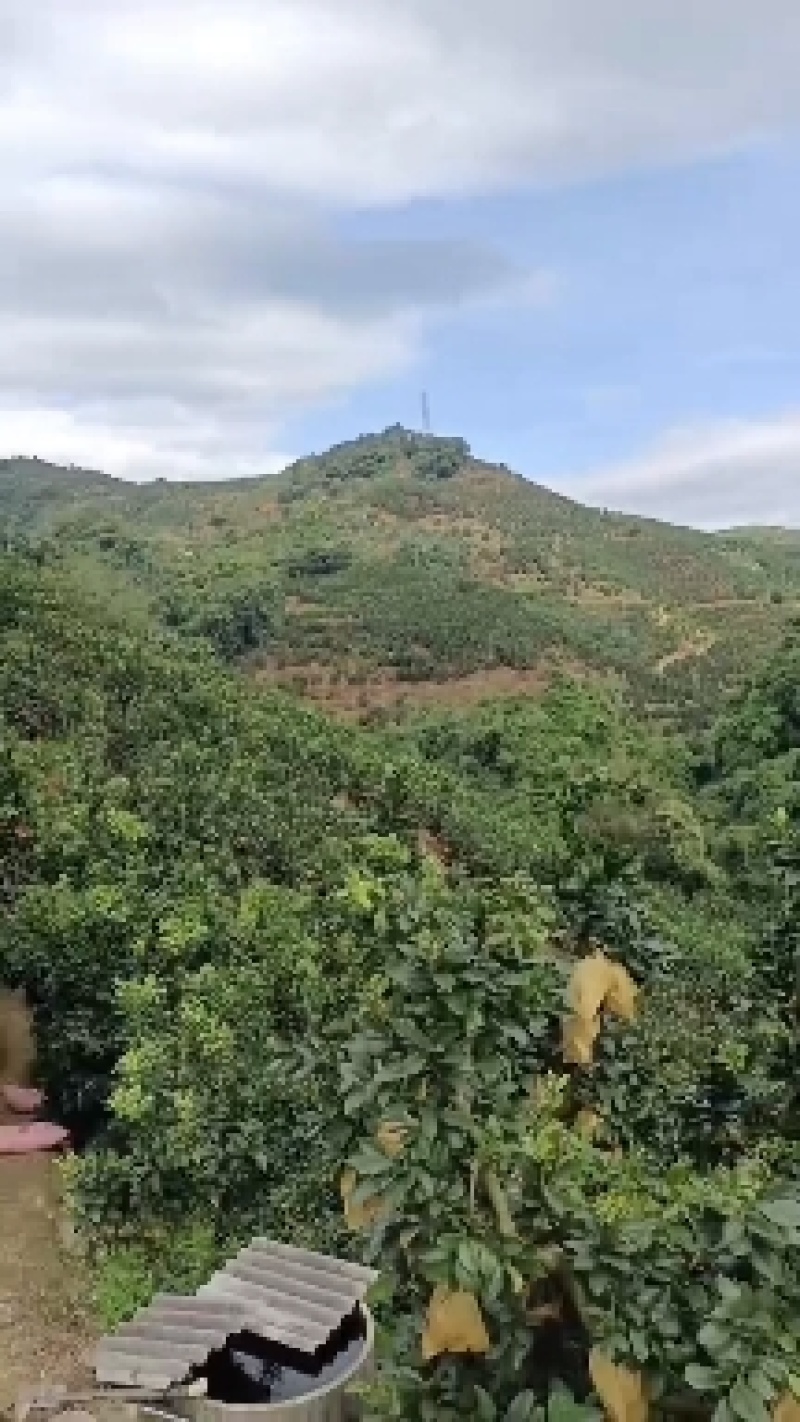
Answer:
[0,169,525,478]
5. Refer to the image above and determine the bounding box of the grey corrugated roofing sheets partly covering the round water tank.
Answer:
[95,1239,378,1391]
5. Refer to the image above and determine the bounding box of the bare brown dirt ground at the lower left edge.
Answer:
[0,1105,92,1412]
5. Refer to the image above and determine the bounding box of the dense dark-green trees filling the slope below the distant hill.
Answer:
[0,546,800,1422]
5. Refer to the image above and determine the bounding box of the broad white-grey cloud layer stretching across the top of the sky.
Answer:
[0,0,800,203]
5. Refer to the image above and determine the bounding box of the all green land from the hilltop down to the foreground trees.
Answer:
[0,429,800,1422]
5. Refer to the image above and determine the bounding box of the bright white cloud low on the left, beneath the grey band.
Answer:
[0,295,426,479]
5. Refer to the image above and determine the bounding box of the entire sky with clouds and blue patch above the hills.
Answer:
[0,0,800,526]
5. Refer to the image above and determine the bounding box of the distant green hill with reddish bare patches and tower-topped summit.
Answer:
[0,427,800,722]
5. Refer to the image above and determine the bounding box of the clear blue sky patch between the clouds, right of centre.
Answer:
[291,144,800,528]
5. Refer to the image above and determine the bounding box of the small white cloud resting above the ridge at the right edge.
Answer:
[574,412,800,528]
